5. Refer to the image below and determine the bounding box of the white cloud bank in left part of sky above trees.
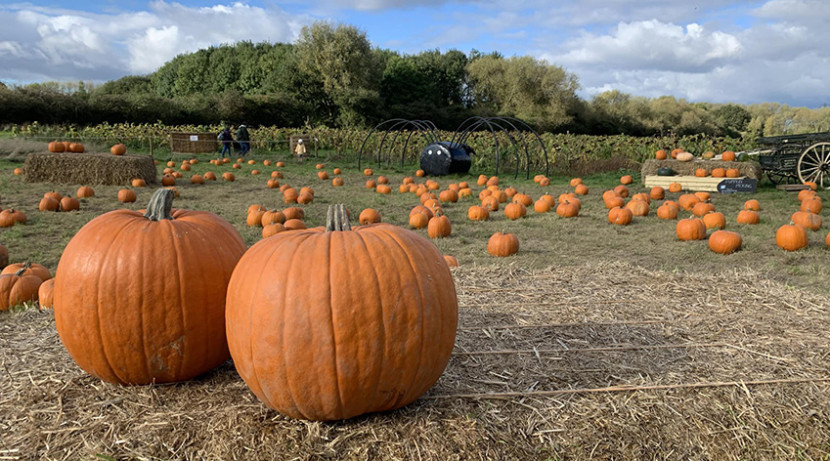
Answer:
[0,1,309,82]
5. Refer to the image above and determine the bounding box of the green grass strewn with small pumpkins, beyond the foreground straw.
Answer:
[0,151,830,292]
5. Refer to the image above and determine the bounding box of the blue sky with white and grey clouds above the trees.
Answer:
[0,0,830,107]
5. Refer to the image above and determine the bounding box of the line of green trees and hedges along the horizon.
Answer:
[0,22,830,137]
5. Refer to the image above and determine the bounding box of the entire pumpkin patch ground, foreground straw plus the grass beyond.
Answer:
[0,142,830,459]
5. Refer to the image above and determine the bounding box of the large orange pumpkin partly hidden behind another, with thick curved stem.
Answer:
[54,189,245,384]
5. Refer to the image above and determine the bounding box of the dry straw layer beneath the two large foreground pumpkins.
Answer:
[0,262,830,460]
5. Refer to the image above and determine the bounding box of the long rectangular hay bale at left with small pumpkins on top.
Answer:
[23,152,156,184]
